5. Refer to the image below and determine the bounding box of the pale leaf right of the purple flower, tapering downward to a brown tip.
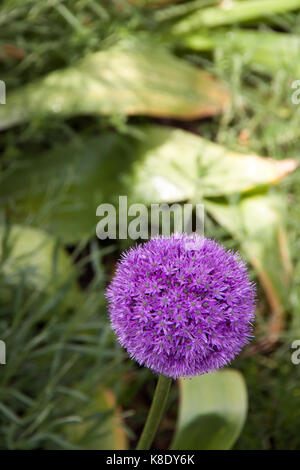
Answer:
[205,193,291,335]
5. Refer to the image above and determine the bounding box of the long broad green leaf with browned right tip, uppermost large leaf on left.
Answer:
[0,40,229,129]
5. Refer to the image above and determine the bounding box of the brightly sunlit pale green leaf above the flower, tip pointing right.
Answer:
[132,126,297,203]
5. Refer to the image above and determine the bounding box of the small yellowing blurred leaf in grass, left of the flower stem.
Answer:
[65,387,128,450]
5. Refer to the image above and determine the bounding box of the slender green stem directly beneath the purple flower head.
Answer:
[137,375,172,450]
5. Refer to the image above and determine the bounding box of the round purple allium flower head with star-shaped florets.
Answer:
[107,234,255,379]
